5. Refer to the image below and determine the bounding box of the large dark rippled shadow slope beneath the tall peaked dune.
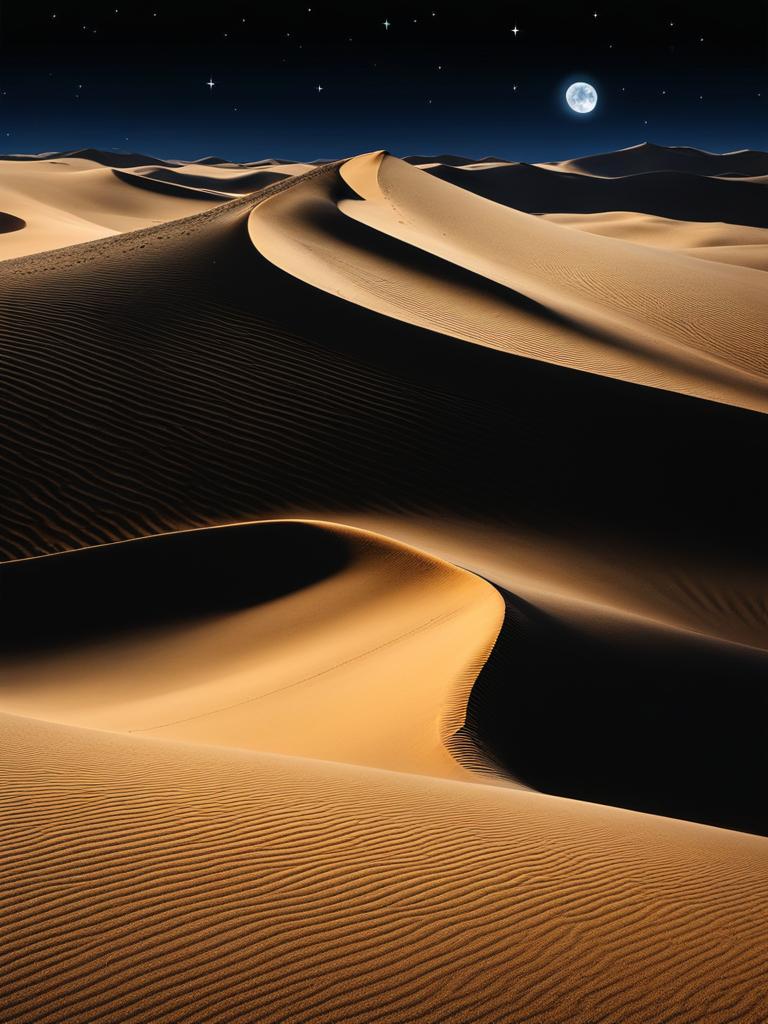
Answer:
[0,159,766,598]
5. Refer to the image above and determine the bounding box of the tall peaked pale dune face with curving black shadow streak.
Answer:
[249,153,768,411]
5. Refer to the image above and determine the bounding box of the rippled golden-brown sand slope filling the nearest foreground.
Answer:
[0,715,768,1024]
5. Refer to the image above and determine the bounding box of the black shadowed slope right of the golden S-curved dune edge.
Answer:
[462,592,768,835]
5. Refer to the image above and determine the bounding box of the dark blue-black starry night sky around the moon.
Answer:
[0,0,768,161]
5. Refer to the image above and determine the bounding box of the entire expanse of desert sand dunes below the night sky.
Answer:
[0,146,768,1024]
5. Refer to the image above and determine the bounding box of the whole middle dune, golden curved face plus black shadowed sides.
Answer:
[0,521,768,833]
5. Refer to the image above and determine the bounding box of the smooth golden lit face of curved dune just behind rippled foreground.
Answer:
[0,520,512,779]
